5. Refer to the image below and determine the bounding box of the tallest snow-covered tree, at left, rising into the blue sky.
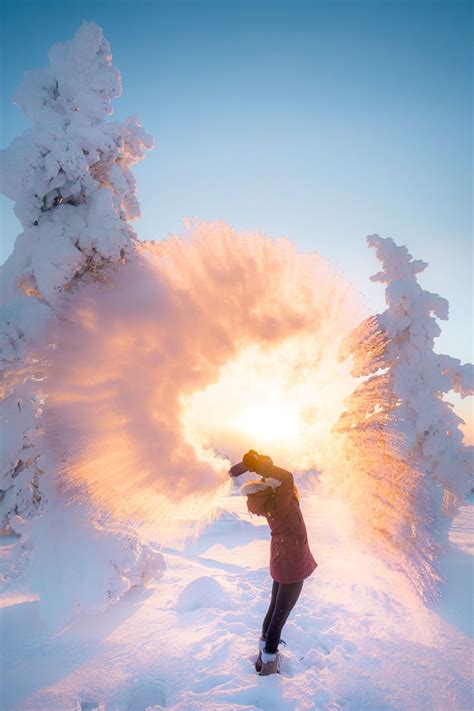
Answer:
[0,22,163,624]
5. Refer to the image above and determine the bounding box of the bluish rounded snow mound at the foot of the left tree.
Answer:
[26,502,166,628]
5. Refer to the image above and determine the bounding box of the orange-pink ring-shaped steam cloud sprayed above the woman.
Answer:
[41,221,363,521]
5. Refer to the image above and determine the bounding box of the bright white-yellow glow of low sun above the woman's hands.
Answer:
[182,335,354,471]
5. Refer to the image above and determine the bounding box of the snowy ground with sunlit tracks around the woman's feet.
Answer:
[0,495,473,711]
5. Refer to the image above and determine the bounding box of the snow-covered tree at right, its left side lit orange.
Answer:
[337,235,474,594]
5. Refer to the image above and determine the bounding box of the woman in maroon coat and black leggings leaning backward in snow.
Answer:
[229,449,318,676]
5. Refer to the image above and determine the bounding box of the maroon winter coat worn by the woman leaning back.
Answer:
[247,464,318,583]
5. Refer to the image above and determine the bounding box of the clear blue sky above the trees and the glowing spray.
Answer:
[0,0,473,368]
